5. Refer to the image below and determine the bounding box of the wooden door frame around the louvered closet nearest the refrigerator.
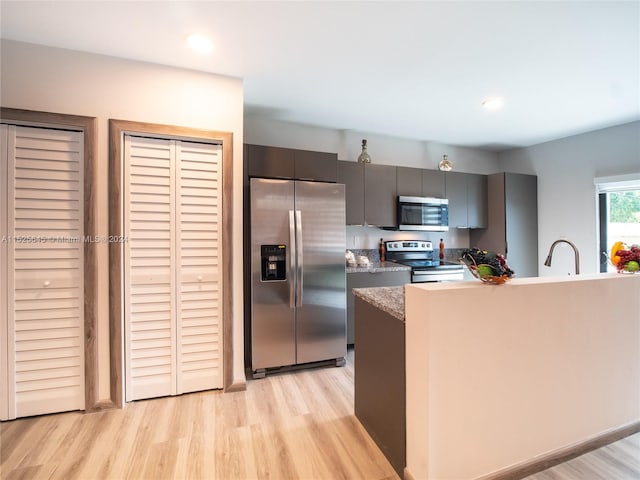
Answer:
[109,119,238,407]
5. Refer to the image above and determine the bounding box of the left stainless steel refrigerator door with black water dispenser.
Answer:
[250,178,296,371]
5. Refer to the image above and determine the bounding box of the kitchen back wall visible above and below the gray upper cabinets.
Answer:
[244,114,500,249]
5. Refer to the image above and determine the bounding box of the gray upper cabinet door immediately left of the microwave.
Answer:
[364,164,397,227]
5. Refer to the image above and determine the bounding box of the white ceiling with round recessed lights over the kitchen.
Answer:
[0,0,640,150]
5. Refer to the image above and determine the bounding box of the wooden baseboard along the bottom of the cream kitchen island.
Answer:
[476,420,640,480]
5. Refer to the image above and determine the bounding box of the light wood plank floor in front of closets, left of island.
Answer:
[0,350,398,480]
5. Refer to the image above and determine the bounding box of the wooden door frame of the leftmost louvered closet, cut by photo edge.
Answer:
[0,107,102,412]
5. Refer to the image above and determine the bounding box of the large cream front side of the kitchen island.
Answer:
[356,274,640,480]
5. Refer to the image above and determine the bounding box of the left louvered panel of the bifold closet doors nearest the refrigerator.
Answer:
[124,136,176,401]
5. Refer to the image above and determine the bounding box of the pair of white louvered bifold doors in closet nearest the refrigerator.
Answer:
[124,136,221,401]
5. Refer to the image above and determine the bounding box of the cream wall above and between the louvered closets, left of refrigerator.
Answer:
[0,40,245,399]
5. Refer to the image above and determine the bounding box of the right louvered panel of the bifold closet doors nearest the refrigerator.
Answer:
[176,142,222,393]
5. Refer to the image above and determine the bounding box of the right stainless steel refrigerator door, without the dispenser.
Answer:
[295,181,347,363]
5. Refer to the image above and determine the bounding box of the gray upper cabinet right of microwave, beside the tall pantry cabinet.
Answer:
[445,172,487,228]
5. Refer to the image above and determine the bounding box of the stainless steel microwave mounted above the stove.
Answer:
[398,196,449,232]
